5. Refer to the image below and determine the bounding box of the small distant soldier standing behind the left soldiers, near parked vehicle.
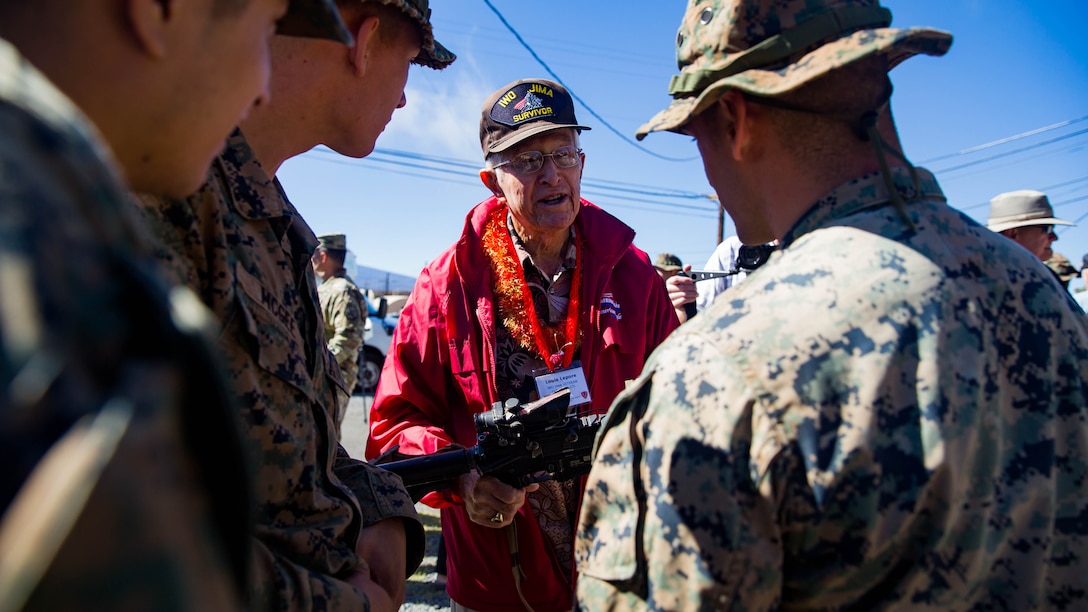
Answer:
[310,234,369,431]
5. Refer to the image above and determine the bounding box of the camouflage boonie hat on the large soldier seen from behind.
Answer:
[636,0,952,140]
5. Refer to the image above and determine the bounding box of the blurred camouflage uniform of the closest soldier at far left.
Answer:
[0,39,249,611]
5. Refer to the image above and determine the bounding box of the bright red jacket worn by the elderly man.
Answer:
[367,197,679,612]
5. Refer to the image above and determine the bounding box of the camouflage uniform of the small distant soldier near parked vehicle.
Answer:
[318,270,369,424]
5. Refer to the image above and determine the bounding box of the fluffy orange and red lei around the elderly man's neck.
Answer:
[481,206,582,371]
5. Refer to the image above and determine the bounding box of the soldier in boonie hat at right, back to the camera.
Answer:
[577,0,1088,610]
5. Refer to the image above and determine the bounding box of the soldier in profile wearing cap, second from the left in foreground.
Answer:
[141,0,454,611]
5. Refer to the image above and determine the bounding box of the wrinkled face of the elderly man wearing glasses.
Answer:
[492,128,585,235]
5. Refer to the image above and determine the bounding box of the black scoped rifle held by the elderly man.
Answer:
[373,389,601,502]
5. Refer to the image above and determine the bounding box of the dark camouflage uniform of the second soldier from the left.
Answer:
[143,131,423,610]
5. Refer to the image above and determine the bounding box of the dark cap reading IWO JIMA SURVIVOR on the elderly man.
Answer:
[480,78,590,157]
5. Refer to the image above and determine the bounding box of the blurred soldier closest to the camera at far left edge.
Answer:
[0,0,347,611]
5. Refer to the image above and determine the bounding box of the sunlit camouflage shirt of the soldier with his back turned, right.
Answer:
[576,169,1088,610]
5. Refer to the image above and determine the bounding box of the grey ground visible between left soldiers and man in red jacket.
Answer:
[341,393,449,612]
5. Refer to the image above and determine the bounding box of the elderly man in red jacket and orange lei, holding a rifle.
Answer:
[367,79,679,612]
